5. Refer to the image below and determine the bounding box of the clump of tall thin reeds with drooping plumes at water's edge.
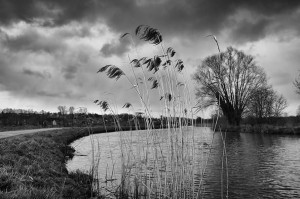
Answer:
[93,25,228,199]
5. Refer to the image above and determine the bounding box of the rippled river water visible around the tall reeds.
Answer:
[67,127,300,199]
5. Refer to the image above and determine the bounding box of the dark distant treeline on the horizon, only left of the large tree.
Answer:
[0,109,196,129]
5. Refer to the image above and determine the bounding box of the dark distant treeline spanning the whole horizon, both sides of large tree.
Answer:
[0,109,300,129]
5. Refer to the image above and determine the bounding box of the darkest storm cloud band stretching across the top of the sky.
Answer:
[0,0,300,42]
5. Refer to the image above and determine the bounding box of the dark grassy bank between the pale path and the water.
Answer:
[0,128,122,199]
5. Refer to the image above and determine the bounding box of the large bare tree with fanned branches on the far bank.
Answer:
[193,47,266,125]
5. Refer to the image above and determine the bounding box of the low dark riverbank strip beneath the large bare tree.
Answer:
[217,124,300,135]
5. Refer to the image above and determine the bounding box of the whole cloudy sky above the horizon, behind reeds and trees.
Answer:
[0,0,300,115]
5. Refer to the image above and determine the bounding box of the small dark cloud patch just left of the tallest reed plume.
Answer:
[100,39,130,57]
